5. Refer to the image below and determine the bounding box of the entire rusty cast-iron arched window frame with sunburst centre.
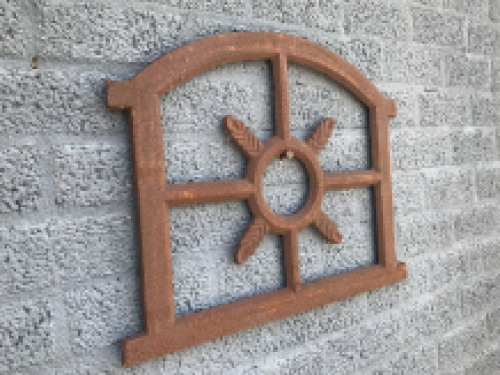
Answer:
[106,32,406,366]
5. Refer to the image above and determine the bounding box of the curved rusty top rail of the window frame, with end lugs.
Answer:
[107,31,396,116]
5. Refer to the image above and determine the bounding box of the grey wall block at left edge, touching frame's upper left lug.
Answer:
[0,67,126,135]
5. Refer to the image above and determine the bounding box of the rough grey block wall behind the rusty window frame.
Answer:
[0,0,500,375]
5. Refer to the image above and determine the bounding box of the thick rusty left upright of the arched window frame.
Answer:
[130,91,175,335]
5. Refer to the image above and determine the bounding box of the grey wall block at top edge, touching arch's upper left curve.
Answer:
[40,1,241,62]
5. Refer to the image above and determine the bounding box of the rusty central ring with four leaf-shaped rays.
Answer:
[224,116,342,288]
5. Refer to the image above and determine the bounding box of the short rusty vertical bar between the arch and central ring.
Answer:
[272,53,290,139]
